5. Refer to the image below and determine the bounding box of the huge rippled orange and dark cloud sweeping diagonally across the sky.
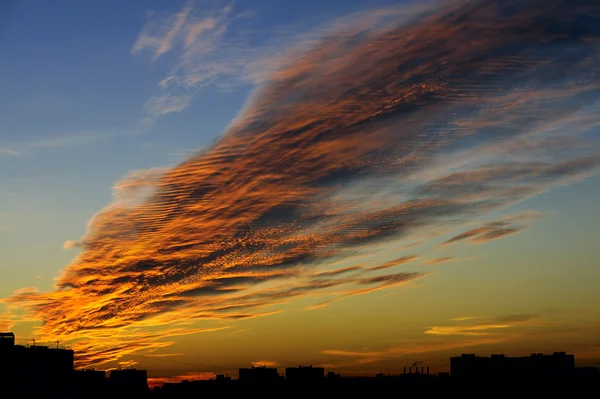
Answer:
[6,0,600,366]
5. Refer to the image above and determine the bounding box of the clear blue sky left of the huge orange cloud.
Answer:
[0,0,418,295]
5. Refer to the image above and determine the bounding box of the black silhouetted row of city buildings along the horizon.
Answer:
[0,333,600,398]
